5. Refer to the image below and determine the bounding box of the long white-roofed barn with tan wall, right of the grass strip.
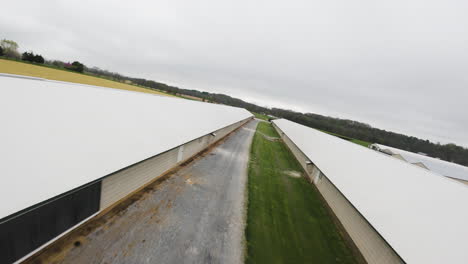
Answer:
[273,119,468,264]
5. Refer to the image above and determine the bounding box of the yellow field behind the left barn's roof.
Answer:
[0,59,169,96]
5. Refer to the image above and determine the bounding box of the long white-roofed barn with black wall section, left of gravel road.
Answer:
[0,75,252,263]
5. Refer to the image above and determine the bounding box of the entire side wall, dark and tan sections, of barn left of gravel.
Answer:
[0,118,252,263]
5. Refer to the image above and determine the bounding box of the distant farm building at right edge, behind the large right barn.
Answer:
[371,144,468,185]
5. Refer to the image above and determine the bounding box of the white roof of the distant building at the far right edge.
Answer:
[373,144,468,181]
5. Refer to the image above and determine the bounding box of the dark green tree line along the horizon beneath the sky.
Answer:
[0,40,468,166]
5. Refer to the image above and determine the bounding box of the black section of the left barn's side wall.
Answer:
[0,181,101,263]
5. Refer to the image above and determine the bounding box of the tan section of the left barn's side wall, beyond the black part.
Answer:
[100,118,250,210]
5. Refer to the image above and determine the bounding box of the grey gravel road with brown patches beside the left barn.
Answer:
[52,120,258,264]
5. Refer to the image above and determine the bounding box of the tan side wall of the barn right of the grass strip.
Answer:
[273,124,404,264]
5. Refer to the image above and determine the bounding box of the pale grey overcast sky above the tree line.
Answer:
[0,0,468,146]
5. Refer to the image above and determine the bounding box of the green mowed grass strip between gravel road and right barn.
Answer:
[246,122,356,263]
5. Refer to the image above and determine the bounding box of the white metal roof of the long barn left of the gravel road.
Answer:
[0,76,251,219]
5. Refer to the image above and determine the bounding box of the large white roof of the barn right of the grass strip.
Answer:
[273,119,468,263]
